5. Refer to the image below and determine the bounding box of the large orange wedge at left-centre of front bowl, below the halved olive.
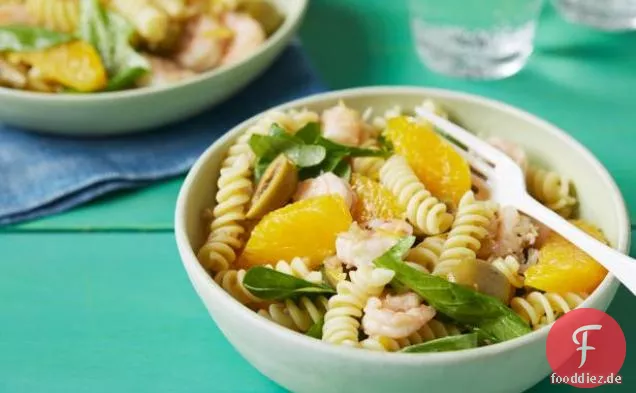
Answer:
[239,195,353,268]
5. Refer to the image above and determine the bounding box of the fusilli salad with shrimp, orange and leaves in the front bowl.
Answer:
[198,100,607,353]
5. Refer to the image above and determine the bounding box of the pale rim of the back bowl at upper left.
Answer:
[0,0,309,103]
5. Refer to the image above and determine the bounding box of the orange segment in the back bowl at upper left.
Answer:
[11,41,107,92]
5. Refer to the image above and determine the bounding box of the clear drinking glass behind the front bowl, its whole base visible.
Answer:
[409,0,544,79]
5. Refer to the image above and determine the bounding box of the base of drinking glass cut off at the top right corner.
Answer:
[553,0,636,31]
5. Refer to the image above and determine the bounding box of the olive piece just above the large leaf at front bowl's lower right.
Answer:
[447,260,514,304]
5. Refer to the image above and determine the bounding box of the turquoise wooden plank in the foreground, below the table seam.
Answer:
[0,233,636,393]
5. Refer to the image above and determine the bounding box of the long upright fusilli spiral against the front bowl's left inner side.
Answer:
[198,153,252,272]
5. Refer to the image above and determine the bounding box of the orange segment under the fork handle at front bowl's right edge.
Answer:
[525,220,607,293]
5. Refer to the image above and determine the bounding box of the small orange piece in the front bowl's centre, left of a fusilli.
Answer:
[351,173,404,224]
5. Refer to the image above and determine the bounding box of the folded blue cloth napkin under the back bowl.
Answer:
[0,41,325,225]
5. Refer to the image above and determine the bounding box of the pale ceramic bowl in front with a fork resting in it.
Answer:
[175,87,630,393]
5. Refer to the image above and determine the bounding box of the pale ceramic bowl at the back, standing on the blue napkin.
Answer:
[0,0,308,136]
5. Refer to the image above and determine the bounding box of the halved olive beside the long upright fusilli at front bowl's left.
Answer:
[245,154,298,220]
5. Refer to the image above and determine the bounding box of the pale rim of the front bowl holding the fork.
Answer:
[174,86,631,365]
